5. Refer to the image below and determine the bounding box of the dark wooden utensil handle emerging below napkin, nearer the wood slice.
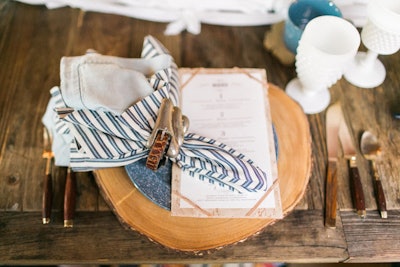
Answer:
[64,168,76,227]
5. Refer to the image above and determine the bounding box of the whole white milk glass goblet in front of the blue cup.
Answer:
[286,16,361,114]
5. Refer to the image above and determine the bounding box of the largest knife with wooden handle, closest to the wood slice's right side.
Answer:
[325,103,341,228]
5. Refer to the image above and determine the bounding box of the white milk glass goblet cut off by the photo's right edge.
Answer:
[344,0,400,88]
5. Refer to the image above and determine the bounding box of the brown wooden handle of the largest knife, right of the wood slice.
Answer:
[325,161,337,228]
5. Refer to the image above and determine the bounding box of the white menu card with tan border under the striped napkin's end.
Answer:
[171,68,282,218]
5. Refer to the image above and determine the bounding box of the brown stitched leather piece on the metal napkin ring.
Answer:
[146,131,169,171]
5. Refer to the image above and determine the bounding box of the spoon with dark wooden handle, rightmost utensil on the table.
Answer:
[360,131,387,218]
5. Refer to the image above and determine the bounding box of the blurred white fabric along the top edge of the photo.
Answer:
[17,0,369,35]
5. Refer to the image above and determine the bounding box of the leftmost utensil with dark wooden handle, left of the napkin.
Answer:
[42,127,54,224]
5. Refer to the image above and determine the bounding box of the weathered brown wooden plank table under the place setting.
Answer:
[0,0,400,264]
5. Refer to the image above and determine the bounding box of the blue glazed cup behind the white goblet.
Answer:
[284,0,342,54]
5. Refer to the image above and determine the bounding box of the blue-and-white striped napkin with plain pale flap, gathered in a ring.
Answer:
[43,36,272,195]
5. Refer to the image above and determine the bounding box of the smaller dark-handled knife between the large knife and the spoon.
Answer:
[339,119,367,218]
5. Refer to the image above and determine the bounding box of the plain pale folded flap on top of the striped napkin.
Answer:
[61,52,172,114]
